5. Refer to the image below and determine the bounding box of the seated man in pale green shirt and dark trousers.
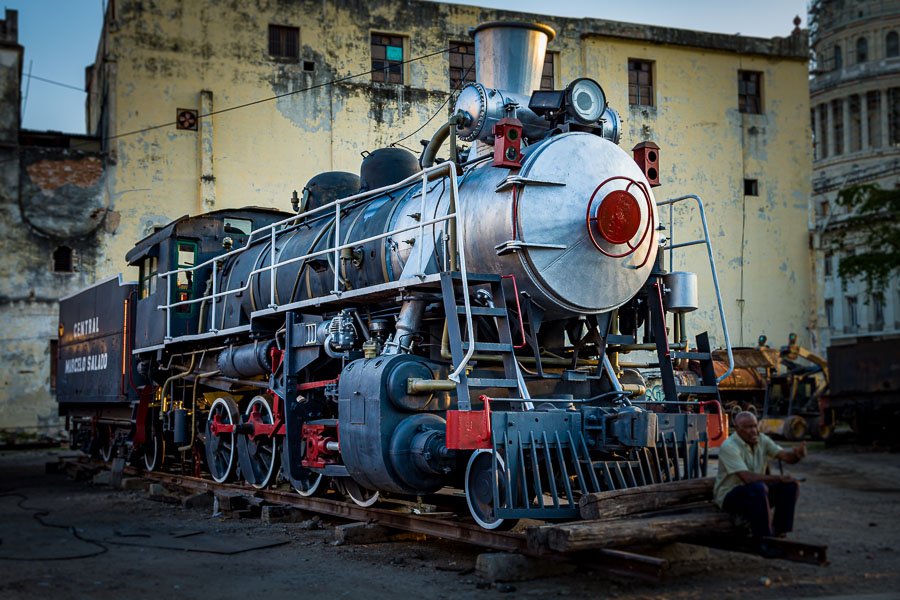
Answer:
[713,412,806,555]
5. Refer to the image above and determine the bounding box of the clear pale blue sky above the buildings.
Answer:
[4,0,807,133]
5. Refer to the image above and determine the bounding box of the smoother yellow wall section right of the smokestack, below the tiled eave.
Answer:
[584,37,811,345]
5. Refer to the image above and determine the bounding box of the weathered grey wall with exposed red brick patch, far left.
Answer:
[0,146,110,430]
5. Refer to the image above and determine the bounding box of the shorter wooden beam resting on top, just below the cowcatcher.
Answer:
[579,477,713,520]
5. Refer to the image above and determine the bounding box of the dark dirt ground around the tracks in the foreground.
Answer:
[0,449,900,600]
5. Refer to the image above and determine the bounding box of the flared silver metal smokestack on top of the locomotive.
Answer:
[471,21,556,96]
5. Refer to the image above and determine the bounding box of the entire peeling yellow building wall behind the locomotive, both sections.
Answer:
[97,0,811,345]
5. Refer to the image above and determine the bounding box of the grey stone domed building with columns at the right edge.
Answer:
[809,0,900,351]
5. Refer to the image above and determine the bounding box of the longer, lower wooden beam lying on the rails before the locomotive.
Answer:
[527,511,737,552]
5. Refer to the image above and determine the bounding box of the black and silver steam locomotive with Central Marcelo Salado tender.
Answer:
[57,23,725,529]
